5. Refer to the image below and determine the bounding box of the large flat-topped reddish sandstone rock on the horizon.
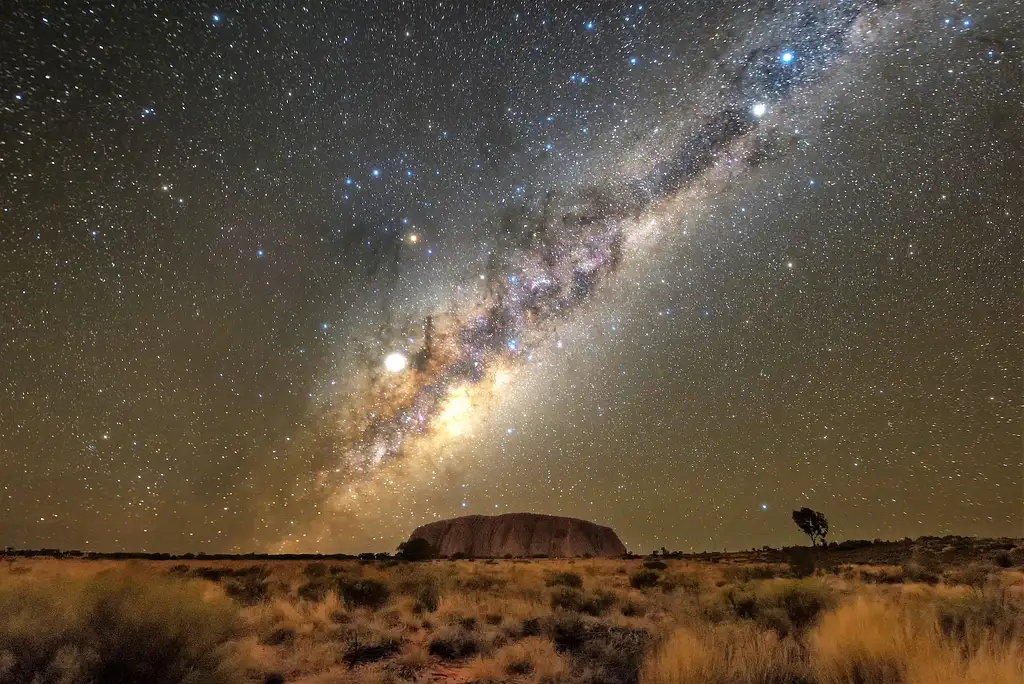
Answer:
[410,513,626,558]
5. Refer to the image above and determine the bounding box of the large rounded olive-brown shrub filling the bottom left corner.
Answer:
[0,572,240,684]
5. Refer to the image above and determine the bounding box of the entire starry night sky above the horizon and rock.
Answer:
[0,0,1024,553]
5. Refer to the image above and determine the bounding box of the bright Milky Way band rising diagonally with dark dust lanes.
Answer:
[260,2,1011,549]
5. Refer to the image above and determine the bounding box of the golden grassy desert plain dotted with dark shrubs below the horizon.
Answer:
[0,538,1024,684]
